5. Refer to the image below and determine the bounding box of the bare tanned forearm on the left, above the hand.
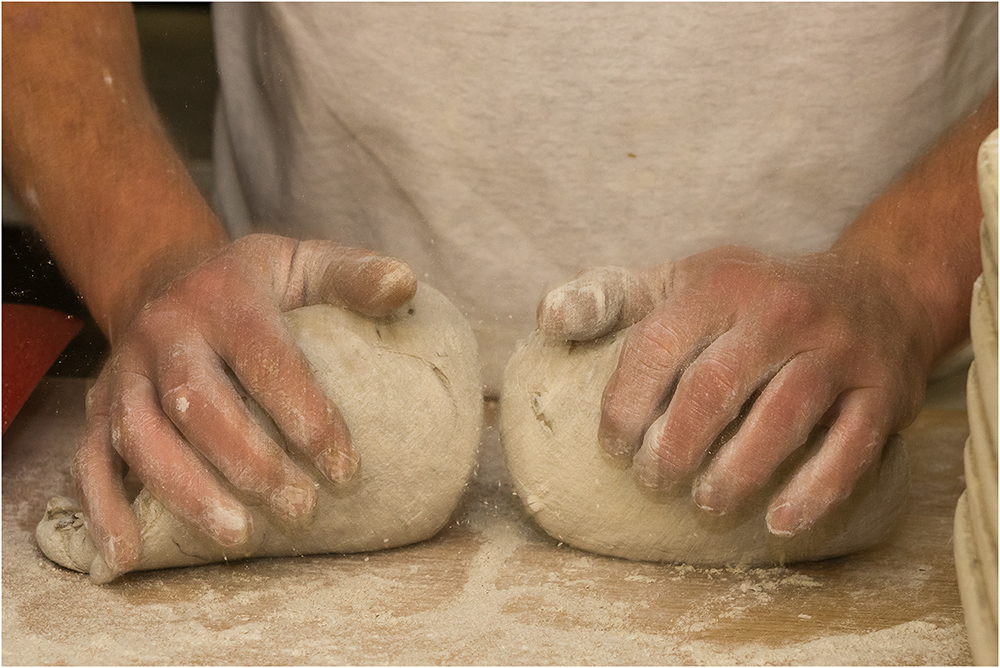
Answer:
[3,3,226,341]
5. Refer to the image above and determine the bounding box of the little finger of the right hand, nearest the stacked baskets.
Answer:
[767,388,889,536]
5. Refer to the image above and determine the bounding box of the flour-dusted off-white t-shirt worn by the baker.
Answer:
[213,3,997,390]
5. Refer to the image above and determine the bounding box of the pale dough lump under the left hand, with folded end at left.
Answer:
[36,284,483,579]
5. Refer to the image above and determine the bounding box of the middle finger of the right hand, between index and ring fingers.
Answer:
[632,328,784,488]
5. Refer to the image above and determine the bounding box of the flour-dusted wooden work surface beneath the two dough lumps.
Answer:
[2,380,971,665]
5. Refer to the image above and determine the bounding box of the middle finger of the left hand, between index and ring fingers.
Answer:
[157,345,316,519]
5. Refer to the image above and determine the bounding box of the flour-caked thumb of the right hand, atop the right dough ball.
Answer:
[537,263,673,341]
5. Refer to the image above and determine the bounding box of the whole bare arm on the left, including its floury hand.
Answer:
[3,4,416,581]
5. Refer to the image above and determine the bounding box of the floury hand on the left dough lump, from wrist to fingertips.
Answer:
[75,235,416,580]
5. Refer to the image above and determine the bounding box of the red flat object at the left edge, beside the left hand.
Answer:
[3,304,83,431]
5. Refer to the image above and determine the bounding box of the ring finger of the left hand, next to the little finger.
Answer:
[111,372,252,547]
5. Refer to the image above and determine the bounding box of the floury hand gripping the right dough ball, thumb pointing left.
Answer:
[538,247,934,536]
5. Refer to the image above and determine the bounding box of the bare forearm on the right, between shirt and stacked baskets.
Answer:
[833,87,997,362]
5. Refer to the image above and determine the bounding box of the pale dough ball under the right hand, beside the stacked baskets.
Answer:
[500,330,909,566]
